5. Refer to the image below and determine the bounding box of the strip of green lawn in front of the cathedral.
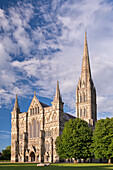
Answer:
[0,163,113,170]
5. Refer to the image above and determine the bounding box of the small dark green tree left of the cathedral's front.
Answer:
[1,146,11,160]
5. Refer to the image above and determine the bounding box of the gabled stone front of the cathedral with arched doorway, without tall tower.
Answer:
[11,82,75,162]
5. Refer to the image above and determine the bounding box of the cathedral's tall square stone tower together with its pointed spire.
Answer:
[76,32,97,127]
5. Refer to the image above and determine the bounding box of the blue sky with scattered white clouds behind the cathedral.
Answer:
[0,0,113,150]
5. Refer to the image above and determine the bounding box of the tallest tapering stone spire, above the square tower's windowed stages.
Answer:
[81,32,91,84]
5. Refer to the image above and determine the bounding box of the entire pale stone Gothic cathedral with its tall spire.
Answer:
[11,33,97,163]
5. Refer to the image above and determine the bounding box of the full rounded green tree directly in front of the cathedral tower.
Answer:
[56,118,92,159]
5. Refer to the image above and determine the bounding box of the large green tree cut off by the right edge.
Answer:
[92,118,113,163]
